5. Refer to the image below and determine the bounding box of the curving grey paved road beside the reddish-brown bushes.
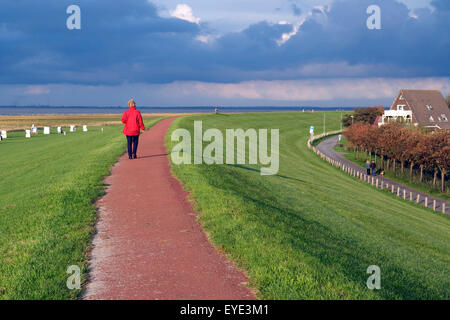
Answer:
[316,136,450,214]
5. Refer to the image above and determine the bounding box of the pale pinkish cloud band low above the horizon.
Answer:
[0,77,450,107]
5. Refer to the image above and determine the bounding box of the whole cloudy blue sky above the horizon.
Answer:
[0,0,450,108]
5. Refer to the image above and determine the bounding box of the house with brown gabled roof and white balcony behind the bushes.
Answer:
[375,89,450,129]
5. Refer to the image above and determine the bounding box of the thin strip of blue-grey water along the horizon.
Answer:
[0,106,354,116]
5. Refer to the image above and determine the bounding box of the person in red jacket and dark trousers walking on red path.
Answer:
[122,99,145,159]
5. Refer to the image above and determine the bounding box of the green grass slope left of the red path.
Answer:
[0,119,159,299]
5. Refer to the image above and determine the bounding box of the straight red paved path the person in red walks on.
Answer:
[84,118,255,300]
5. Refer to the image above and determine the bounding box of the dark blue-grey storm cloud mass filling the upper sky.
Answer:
[0,0,450,84]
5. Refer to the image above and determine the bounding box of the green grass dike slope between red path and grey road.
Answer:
[166,113,450,299]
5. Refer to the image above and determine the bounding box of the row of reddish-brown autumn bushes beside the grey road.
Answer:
[344,122,450,192]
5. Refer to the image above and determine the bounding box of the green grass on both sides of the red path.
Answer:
[0,113,450,299]
